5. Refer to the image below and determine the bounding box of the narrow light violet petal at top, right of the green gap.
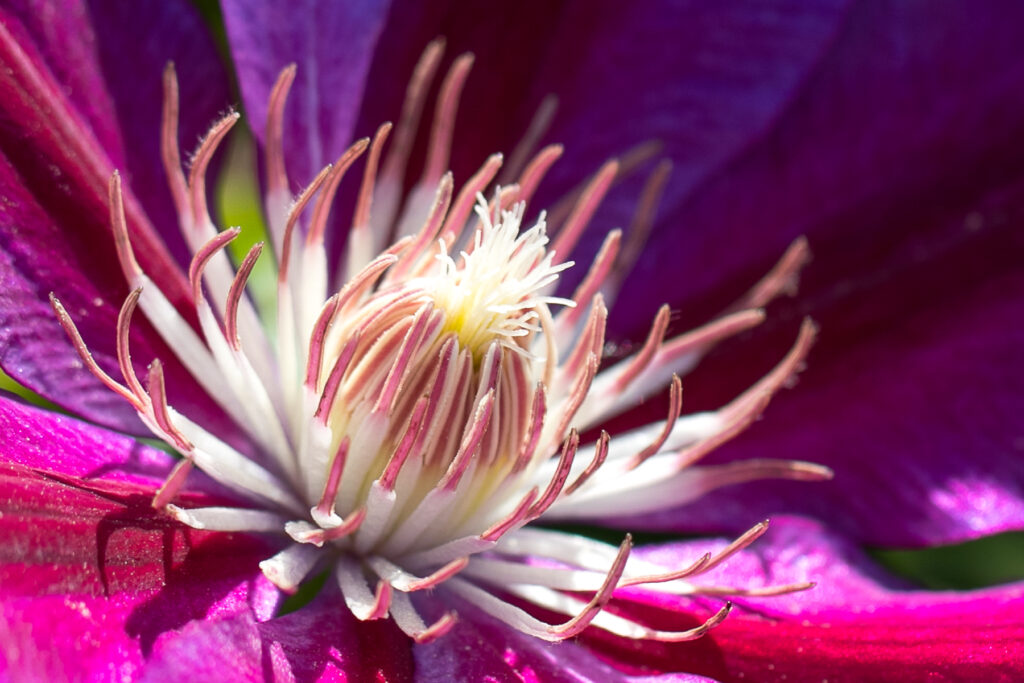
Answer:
[222,0,390,189]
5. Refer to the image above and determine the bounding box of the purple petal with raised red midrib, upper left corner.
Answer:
[0,2,243,444]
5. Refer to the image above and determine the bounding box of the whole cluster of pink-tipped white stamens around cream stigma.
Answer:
[51,41,830,642]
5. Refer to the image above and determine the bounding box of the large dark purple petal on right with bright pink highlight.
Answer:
[532,2,1024,545]
